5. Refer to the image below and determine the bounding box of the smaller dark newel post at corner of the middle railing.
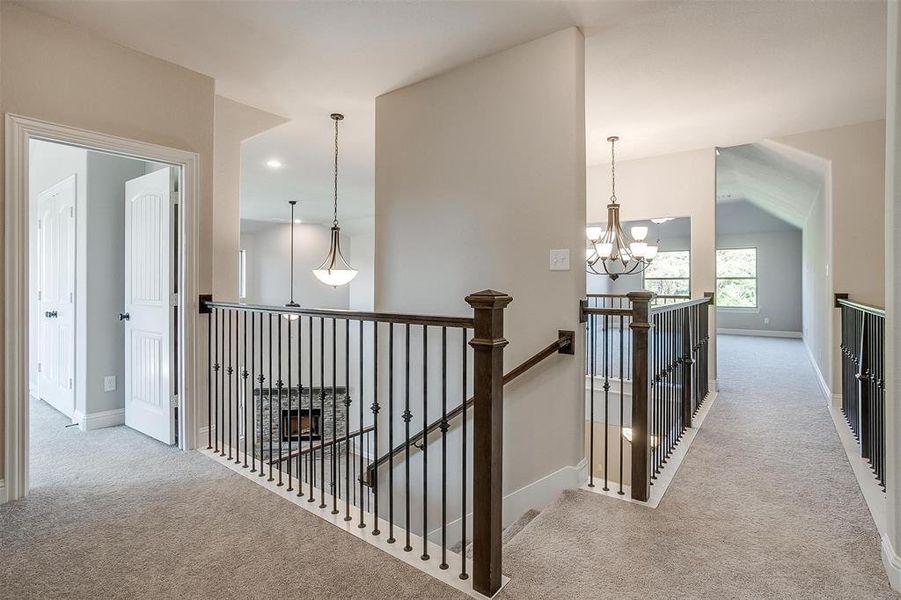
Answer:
[627,290,656,502]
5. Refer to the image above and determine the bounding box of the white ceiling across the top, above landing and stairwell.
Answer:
[23,0,885,222]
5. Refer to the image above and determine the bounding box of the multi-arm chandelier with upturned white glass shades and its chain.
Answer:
[586,135,658,280]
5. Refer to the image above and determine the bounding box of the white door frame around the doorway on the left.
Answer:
[0,113,200,503]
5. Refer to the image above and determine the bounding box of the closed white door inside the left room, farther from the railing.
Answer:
[32,174,76,418]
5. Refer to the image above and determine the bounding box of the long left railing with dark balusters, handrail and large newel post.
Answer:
[200,290,512,597]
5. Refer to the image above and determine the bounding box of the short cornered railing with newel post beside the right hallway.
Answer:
[581,290,713,501]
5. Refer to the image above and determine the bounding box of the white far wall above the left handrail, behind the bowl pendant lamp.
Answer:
[235,223,348,308]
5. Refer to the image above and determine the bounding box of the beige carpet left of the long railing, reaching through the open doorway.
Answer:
[0,401,466,600]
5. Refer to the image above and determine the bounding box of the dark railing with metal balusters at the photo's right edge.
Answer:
[835,293,886,491]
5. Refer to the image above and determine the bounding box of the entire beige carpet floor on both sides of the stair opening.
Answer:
[0,338,897,600]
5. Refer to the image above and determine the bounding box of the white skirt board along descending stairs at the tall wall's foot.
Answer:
[429,458,588,547]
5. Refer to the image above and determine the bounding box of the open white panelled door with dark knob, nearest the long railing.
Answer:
[125,168,176,444]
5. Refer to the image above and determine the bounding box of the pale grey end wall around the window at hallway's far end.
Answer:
[716,231,801,334]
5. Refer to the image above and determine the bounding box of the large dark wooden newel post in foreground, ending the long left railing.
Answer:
[466,290,513,598]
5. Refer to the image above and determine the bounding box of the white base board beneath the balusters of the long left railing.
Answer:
[198,445,510,600]
